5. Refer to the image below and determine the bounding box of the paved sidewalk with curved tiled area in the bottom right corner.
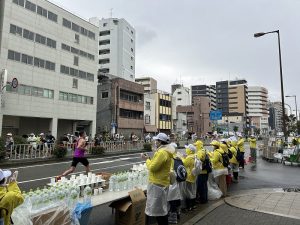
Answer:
[183,189,300,225]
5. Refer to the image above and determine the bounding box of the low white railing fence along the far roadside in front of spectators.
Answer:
[7,141,144,160]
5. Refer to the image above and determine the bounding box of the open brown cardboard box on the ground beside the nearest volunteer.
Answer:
[109,189,146,225]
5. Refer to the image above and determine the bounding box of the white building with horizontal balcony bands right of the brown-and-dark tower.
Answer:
[248,86,269,134]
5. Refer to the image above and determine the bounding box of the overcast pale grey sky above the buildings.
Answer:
[51,0,300,108]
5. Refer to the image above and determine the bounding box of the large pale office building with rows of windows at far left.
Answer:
[0,0,98,137]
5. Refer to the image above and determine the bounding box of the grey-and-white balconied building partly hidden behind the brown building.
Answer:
[191,85,216,110]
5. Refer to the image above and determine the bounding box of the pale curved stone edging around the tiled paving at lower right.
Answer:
[224,188,300,220]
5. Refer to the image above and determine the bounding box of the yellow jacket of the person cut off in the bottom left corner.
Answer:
[0,182,24,225]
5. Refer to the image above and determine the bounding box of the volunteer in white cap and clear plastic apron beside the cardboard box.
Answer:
[142,133,175,225]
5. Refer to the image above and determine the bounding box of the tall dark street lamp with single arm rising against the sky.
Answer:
[254,30,287,140]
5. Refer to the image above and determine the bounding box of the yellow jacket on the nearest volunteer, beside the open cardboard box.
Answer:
[146,145,175,187]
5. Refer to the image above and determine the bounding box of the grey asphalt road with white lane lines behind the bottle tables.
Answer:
[10,153,142,191]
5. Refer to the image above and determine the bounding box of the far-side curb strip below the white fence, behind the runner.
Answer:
[1,150,145,168]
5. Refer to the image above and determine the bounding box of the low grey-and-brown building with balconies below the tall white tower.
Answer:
[97,78,144,139]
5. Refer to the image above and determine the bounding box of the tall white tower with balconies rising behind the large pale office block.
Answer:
[90,17,135,82]
